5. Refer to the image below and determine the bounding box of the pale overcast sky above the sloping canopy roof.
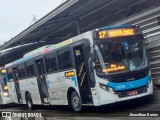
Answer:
[0,0,65,45]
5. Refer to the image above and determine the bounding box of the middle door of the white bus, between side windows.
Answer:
[36,58,49,104]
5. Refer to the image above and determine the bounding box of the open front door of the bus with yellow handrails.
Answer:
[73,45,92,104]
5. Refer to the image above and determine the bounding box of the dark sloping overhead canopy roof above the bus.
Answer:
[0,0,160,65]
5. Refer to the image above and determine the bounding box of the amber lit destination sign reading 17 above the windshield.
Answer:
[98,28,136,39]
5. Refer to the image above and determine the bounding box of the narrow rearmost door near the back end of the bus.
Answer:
[13,67,22,103]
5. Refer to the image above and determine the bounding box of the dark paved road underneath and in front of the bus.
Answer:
[1,90,160,120]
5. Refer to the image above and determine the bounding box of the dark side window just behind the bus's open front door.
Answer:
[58,50,72,70]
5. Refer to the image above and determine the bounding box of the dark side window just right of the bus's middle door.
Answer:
[45,54,57,73]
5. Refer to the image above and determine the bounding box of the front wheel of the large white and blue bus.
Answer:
[71,91,82,112]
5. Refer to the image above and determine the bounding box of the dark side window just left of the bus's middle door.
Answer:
[26,61,35,77]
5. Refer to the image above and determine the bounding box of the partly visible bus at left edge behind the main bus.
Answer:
[0,67,11,105]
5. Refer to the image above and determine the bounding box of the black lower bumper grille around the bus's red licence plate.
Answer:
[116,86,147,98]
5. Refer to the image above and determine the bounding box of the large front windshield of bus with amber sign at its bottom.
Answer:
[96,31,146,74]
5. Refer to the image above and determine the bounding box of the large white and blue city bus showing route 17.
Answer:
[5,25,153,111]
